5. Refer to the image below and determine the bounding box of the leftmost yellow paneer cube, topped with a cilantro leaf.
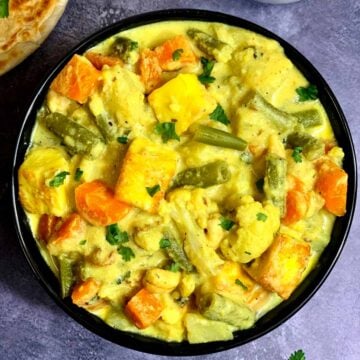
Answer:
[19,147,70,216]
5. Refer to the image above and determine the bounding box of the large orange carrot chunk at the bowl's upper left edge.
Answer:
[50,54,100,104]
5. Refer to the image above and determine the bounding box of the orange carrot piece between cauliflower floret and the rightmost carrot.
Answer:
[282,176,309,225]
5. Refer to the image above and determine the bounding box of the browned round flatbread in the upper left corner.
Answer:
[0,0,68,75]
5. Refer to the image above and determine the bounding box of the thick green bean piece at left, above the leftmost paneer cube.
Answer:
[42,112,103,157]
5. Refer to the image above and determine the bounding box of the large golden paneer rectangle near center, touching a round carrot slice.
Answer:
[115,138,177,213]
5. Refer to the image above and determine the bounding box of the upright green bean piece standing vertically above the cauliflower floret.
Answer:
[264,154,287,216]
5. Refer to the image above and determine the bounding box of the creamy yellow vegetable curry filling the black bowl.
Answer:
[19,21,347,343]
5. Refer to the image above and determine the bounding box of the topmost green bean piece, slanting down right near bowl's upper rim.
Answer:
[186,28,232,62]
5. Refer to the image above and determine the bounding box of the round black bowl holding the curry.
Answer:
[12,9,357,356]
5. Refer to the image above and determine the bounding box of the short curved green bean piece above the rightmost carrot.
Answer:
[286,132,325,160]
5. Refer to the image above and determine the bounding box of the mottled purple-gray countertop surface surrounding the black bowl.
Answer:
[0,0,360,360]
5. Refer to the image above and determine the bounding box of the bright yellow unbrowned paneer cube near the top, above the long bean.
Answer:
[148,74,216,134]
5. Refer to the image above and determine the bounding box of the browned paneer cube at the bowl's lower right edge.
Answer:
[244,234,311,299]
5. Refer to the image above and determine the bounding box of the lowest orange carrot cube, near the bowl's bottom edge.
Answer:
[125,288,164,329]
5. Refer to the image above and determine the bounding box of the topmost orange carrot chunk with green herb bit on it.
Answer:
[154,35,197,71]
